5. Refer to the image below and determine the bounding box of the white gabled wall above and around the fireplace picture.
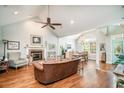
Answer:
[2,20,58,57]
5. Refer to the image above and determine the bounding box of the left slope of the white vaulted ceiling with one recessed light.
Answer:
[0,5,43,26]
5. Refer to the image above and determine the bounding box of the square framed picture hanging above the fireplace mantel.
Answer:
[31,35,42,45]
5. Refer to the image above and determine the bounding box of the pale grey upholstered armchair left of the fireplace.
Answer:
[8,52,28,69]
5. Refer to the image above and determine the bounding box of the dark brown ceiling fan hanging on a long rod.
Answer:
[37,5,62,30]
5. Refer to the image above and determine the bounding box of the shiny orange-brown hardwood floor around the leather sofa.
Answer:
[0,61,115,88]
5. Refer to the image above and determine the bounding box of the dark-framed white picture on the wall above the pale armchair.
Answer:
[7,41,20,50]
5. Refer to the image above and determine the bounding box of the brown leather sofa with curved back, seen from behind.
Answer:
[33,59,80,84]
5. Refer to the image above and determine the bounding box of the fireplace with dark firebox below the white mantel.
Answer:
[29,49,44,61]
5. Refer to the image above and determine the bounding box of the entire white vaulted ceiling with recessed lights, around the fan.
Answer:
[0,5,124,37]
